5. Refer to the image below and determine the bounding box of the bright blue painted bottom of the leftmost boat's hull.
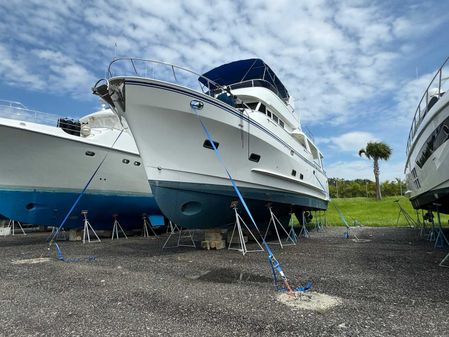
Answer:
[0,190,160,229]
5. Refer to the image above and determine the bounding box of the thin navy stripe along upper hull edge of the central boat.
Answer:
[125,80,323,173]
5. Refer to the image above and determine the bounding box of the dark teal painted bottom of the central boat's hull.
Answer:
[151,181,327,228]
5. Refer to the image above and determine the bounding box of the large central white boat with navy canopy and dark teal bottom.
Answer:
[93,58,329,228]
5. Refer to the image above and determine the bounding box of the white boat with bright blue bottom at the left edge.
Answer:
[0,101,160,229]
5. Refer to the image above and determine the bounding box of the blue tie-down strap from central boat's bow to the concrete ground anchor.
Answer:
[192,106,311,293]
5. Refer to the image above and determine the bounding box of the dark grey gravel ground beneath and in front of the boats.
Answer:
[0,228,449,337]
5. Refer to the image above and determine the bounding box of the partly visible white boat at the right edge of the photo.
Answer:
[405,58,449,213]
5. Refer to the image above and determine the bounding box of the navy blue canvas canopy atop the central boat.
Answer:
[198,59,290,103]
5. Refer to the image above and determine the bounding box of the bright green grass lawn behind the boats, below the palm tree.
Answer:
[326,197,449,227]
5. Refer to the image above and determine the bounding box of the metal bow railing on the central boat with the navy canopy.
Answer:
[107,57,226,93]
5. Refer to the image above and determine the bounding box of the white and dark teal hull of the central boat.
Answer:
[110,79,328,228]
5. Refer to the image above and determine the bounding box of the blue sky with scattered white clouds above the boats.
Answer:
[0,0,449,180]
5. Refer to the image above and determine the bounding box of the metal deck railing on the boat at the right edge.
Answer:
[406,57,449,156]
